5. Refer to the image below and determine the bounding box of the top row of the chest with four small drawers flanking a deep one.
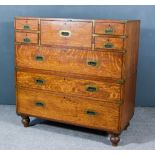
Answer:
[15,17,140,50]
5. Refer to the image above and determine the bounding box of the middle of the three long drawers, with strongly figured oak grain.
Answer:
[17,72,121,101]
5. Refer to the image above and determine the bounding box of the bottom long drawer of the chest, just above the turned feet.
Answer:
[17,89,119,131]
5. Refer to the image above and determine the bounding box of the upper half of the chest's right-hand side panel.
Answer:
[122,22,140,79]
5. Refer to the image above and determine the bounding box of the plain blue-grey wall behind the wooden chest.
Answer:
[0,6,155,106]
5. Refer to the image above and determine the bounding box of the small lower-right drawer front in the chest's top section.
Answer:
[95,37,124,50]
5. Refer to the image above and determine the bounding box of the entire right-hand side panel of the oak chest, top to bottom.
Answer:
[121,21,140,129]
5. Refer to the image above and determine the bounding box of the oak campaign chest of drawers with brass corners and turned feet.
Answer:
[15,17,140,145]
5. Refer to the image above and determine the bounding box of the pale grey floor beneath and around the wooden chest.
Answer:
[0,105,155,150]
